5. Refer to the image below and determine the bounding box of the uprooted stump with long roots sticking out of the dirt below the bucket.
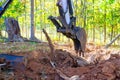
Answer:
[43,29,88,80]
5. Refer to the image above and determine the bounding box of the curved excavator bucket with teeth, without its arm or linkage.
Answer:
[72,27,87,56]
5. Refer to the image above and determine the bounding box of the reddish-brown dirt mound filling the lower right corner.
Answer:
[62,55,120,80]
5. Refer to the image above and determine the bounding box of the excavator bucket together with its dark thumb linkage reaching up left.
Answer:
[48,16,87,56]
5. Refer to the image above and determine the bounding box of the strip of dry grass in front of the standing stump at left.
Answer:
[0,42,49,53]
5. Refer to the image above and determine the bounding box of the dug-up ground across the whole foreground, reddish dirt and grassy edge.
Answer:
[1,43,120,80]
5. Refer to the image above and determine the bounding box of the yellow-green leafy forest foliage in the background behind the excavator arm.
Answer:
[0,0,120,42]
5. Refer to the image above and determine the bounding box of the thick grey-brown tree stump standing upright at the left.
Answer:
[5,18,27,42]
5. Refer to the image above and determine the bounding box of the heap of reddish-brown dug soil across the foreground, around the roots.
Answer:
[11,50,120,80]
